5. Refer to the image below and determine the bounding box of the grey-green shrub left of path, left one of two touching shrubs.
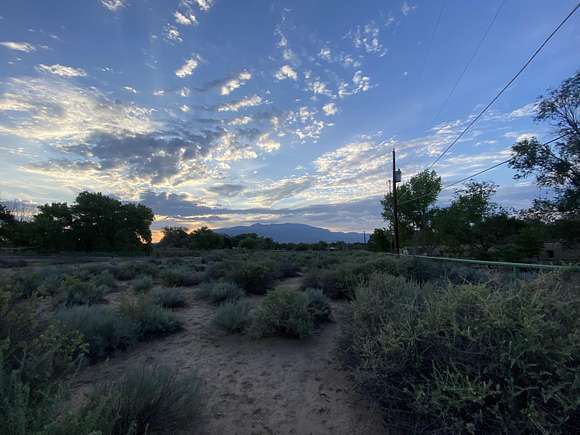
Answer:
[56,306,139,361]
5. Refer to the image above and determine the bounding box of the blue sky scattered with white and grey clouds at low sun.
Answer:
[0,0,580,238]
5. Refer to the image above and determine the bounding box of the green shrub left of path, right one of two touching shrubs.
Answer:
[119,297,181,339]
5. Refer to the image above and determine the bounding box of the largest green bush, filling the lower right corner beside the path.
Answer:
[341,275,580,433]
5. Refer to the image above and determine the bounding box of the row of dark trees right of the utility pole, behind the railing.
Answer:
[369,72,580,260]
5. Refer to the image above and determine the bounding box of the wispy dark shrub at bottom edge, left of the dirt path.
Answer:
[56,367,202,435]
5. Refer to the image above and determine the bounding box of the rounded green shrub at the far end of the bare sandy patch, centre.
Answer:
[251,289,313,338]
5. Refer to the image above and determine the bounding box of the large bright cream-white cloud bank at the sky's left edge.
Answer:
[0,77,156,142]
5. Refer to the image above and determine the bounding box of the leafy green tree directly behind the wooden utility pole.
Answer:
[381,170,441,247]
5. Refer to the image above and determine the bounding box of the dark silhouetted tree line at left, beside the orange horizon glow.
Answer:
[0,192,154,252]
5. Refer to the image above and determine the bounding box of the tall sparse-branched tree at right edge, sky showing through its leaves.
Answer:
[510,71,580,218]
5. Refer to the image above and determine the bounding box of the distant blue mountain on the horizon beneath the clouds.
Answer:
[215,224,363,243]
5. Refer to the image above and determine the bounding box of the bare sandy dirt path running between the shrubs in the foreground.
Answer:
[71,279,383,435]
